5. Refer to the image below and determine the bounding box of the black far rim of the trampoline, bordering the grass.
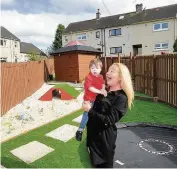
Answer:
[116,122,177,130]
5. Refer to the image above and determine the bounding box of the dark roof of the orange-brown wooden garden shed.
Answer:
[53,45,102,54]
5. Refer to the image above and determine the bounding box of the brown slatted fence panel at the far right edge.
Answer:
[156,55,177,106]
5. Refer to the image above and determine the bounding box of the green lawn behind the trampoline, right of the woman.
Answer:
[121,100,177,126]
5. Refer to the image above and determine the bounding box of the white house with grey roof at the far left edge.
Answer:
[0,27,20,62]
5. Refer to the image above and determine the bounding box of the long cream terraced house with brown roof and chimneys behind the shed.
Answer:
[62,4,177,56]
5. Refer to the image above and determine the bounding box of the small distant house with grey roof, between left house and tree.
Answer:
[19,42,46,62]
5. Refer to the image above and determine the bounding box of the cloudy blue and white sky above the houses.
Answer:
[0,0,177,51]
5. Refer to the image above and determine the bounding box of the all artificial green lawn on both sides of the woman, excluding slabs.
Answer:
[1,100,177,168]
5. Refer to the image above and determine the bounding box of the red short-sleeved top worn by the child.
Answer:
[84,73,105,102]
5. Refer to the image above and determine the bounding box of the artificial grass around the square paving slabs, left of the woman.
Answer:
[1,111,92,168]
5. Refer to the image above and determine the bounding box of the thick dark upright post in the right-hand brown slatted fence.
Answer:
[153,55,157,97]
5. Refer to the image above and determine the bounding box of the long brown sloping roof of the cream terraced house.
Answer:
[64,4,177,33]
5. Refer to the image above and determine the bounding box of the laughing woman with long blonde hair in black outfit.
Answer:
[83,63,134,168]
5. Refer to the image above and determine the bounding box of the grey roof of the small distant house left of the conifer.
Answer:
[20,42,46,56]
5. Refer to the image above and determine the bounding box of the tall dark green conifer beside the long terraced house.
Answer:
[52,24,65,50]
